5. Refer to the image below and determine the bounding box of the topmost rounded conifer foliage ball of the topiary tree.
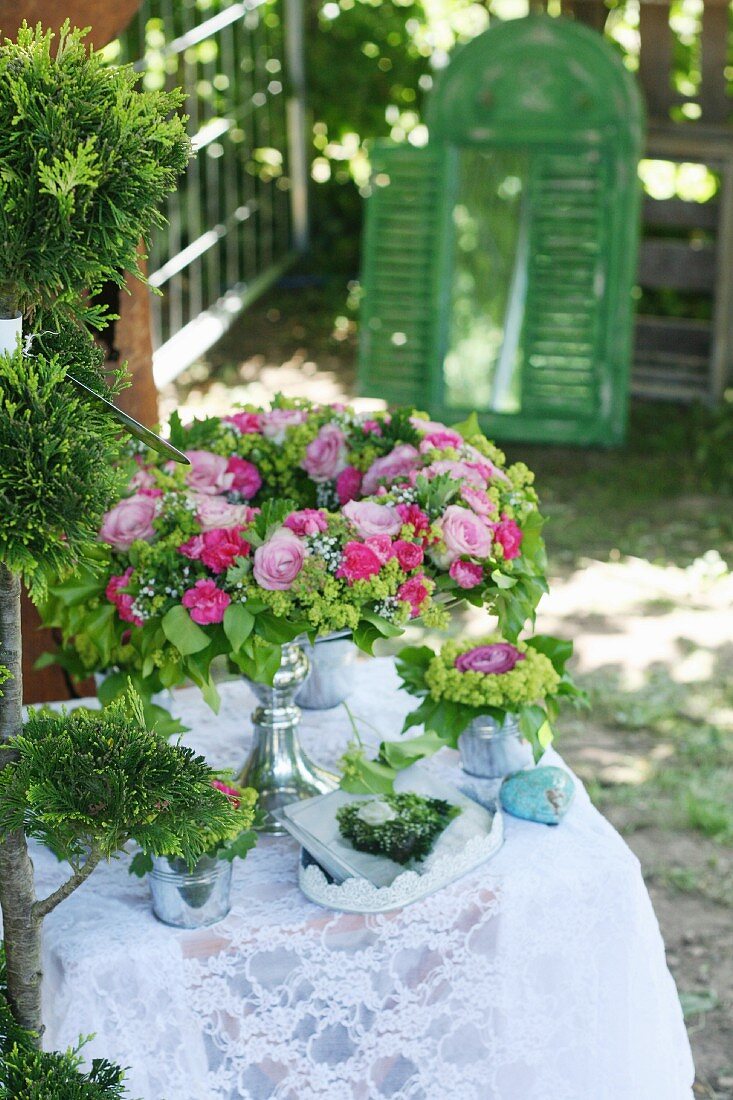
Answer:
[0,23,190,328]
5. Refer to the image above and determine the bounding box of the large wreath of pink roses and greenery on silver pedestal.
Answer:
[39,398,546,707]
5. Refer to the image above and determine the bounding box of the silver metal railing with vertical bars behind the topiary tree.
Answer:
[110,0,308,385]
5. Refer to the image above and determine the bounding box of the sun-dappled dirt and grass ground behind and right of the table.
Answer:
[162,284,733,1100]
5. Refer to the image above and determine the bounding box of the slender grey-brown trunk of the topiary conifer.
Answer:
[0,564,43,1042]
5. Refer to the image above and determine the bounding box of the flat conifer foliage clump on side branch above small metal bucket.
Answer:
[0,696,252,867]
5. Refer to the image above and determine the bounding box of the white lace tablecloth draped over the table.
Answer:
[22,660,693,1100]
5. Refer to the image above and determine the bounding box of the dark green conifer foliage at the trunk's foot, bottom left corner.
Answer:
[0,945,129,1100]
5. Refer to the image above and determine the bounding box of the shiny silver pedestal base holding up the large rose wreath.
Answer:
[237,642,338,834]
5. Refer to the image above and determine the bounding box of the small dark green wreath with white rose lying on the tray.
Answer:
[336,793,461,864]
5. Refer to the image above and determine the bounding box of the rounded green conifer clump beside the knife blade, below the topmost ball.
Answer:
[0,351,123,595]
